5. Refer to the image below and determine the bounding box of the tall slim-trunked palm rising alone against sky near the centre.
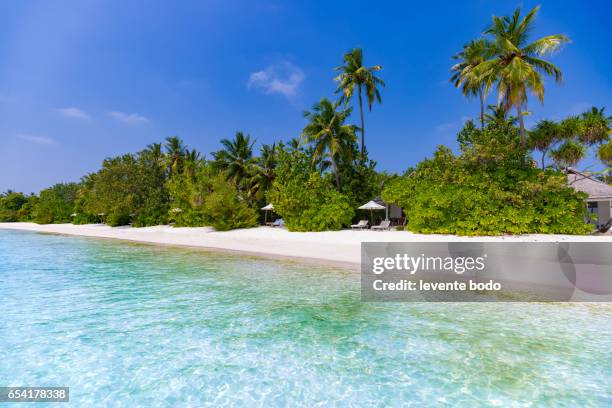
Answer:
[334,48,385,157]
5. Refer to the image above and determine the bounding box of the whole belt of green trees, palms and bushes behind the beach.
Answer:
[0,7,612,235]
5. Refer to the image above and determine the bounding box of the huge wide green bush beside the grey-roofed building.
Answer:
[383,128,590,235]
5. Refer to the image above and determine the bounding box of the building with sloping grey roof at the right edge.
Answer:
[567,168,612,228]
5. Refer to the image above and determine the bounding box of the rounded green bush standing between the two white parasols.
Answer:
[268,151,354,231]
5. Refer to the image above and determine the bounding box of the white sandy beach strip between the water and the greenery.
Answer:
[0,223,612,267]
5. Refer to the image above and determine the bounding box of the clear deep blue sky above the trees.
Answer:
[0,0,612,192]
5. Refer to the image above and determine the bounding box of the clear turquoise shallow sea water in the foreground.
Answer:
[0,230,612,407]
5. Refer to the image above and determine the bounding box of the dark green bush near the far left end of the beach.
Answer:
[33,183,79,224]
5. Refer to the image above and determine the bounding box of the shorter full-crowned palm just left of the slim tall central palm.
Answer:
[302,98,358,189]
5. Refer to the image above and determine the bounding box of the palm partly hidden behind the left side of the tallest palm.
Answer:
[451,39,492,129]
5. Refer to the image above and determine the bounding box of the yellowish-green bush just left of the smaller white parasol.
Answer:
[203,173,258,231]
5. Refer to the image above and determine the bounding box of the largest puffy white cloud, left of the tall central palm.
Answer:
[247,61,305,98]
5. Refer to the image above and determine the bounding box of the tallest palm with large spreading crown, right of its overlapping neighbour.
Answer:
[474,6,569,146]
